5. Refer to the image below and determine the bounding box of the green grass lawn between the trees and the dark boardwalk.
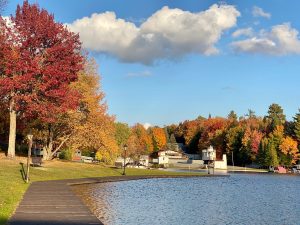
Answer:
[0,159,201,225]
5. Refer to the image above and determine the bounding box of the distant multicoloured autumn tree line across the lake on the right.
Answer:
[166,104,300,166]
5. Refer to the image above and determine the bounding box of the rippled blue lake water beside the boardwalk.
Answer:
[74,174,300,225]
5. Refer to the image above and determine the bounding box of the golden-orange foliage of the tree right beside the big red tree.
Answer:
[66,60,120,164]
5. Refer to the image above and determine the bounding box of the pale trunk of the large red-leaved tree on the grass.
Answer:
[7,99,17,158]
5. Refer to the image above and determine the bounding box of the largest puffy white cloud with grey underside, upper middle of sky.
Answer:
[67,4,240,64]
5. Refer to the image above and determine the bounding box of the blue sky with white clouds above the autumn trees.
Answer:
[5,0,300,125]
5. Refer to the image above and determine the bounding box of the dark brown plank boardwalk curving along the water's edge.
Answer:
[9,176,226,225]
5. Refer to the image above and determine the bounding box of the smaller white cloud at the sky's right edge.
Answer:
[231,23,300,55]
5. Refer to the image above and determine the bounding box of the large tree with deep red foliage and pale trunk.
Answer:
[0,1,84,157]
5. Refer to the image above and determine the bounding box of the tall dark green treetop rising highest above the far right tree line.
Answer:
[266,103,285,131]
